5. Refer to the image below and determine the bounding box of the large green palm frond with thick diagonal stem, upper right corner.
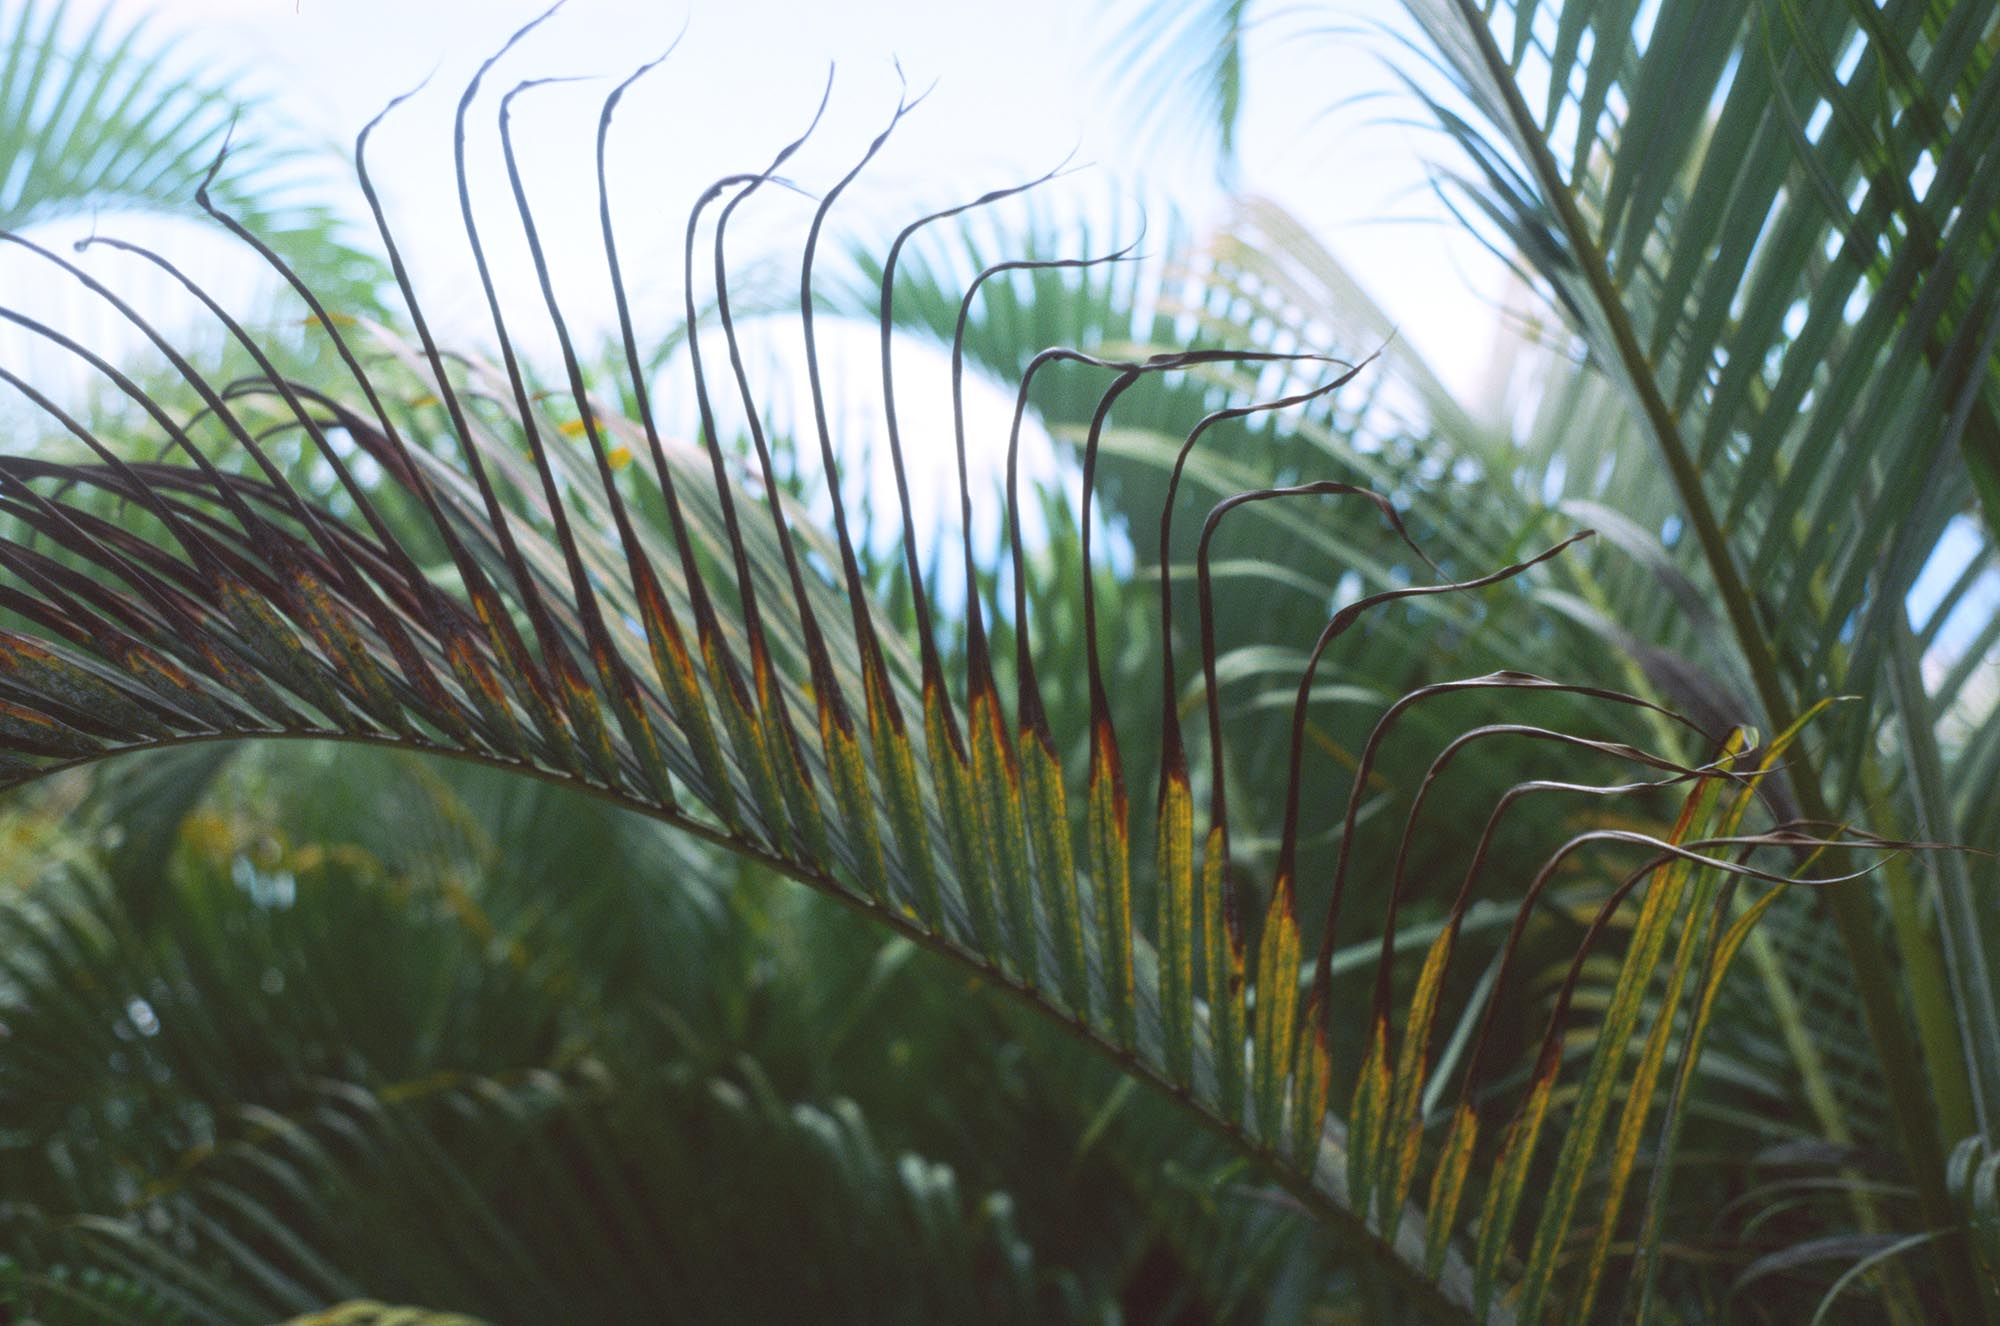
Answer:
[1412,4,2000,1320]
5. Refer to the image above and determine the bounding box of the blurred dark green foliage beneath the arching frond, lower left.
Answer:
[0,746,1192,1322]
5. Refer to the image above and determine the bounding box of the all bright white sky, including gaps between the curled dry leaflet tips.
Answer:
[0,0,1502,560]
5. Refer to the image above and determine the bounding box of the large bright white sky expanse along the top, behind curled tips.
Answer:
[94,0,1498,384]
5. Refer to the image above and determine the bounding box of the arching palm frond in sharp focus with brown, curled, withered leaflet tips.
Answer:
[0,15,1890,1320]
